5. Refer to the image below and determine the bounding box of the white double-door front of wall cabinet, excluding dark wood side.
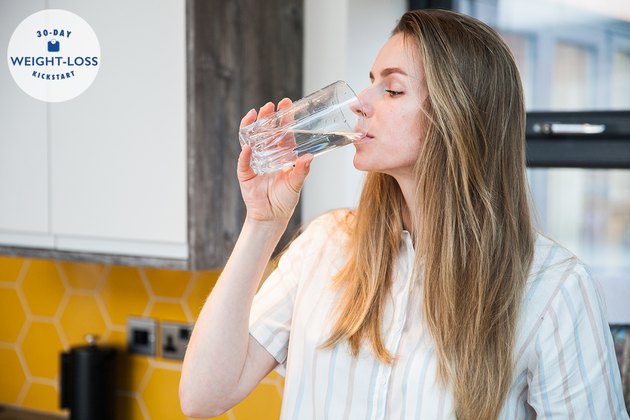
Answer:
[0,0,188,259]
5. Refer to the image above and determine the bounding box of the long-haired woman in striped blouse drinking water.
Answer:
[180,10,628,419]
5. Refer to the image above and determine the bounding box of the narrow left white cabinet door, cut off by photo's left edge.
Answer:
[0,1,53,247]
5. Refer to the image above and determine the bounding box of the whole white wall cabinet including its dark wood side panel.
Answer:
[0,0,303,269]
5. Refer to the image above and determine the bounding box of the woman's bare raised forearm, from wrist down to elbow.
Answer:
[180,220,286,410]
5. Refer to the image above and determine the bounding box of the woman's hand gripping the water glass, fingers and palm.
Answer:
[237,98,313,223]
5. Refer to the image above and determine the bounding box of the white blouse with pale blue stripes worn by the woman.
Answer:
[250,211,628,420]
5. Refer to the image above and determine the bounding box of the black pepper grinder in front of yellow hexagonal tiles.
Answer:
[60,334,117,420]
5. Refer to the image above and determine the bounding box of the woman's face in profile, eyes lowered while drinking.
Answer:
[354,34,426,177]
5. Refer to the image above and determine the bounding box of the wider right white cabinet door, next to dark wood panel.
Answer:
[49,0,187,258]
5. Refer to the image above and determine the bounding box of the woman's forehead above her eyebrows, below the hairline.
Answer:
[372,34,423,79]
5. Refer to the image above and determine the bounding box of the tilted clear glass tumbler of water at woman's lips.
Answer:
[238,80,368,175]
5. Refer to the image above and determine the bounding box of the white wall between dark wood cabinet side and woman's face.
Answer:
[302,0,407,223]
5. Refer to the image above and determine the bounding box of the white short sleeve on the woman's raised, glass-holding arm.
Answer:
[249,214,346,373]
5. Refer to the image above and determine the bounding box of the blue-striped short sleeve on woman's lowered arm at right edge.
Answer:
[528,263,628,419]
